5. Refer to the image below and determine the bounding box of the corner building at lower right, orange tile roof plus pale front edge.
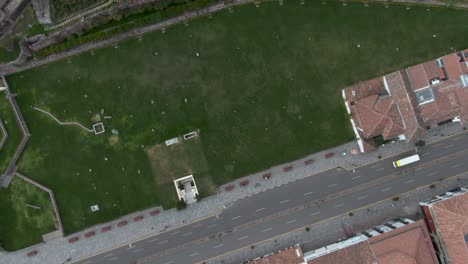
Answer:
[421,188,468,264]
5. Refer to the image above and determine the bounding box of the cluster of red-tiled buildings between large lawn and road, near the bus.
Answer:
[342,50,468,152]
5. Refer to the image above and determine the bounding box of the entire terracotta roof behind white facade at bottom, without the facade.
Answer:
[308,220,439,264]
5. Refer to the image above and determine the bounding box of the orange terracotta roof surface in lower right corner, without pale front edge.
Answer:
[432,194,468,264]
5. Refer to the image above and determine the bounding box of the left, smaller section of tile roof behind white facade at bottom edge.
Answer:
[307,241,377,264]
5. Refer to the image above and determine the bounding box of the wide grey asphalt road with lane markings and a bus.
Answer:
[77,133,468,264]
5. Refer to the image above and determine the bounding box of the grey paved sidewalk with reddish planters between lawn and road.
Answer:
[0,123,464,264]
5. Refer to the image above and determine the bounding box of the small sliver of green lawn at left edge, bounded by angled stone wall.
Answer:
[0,92,23,174]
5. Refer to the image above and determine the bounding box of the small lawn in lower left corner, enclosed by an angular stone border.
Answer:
[0,177,55,251]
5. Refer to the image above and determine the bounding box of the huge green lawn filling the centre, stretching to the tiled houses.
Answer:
[4,1,468,233]
